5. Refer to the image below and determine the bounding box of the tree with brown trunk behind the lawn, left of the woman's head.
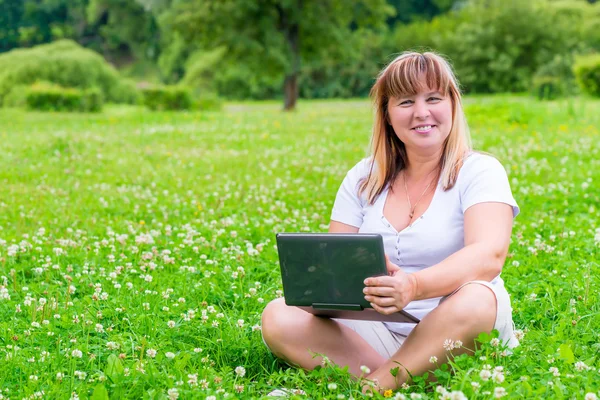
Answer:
[156,0,394,110]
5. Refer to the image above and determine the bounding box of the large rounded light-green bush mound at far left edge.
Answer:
[0,40,139,105]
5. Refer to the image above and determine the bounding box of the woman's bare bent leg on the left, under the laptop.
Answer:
[262,298,385,376]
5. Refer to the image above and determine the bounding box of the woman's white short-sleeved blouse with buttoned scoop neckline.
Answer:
[331,152,519,335]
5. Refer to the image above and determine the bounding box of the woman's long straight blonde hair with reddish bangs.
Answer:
[359,52,471,204]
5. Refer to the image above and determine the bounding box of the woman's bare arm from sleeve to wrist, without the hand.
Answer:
[413,202,513,300]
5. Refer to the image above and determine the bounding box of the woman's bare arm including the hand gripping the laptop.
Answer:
[364,202,513,314]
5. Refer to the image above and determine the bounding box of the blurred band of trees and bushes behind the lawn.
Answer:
[0,0,600,111]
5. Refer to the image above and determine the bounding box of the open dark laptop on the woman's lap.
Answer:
[276,233,419,323]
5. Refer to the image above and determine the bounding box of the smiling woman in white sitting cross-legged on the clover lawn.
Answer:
[262,52,519,389]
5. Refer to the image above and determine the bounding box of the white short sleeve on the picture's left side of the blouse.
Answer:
[331,159,370,228]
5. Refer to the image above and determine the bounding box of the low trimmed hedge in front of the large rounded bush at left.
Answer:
[18,82,103,112]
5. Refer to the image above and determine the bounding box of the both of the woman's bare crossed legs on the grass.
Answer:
[262,284,497,388]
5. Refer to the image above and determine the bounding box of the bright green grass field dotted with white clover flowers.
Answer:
[0,96,600,399]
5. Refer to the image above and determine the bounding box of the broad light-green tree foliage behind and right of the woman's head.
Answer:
[389,0,598,92]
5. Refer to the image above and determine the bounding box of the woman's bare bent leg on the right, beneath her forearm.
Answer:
[367,283,497,389]
